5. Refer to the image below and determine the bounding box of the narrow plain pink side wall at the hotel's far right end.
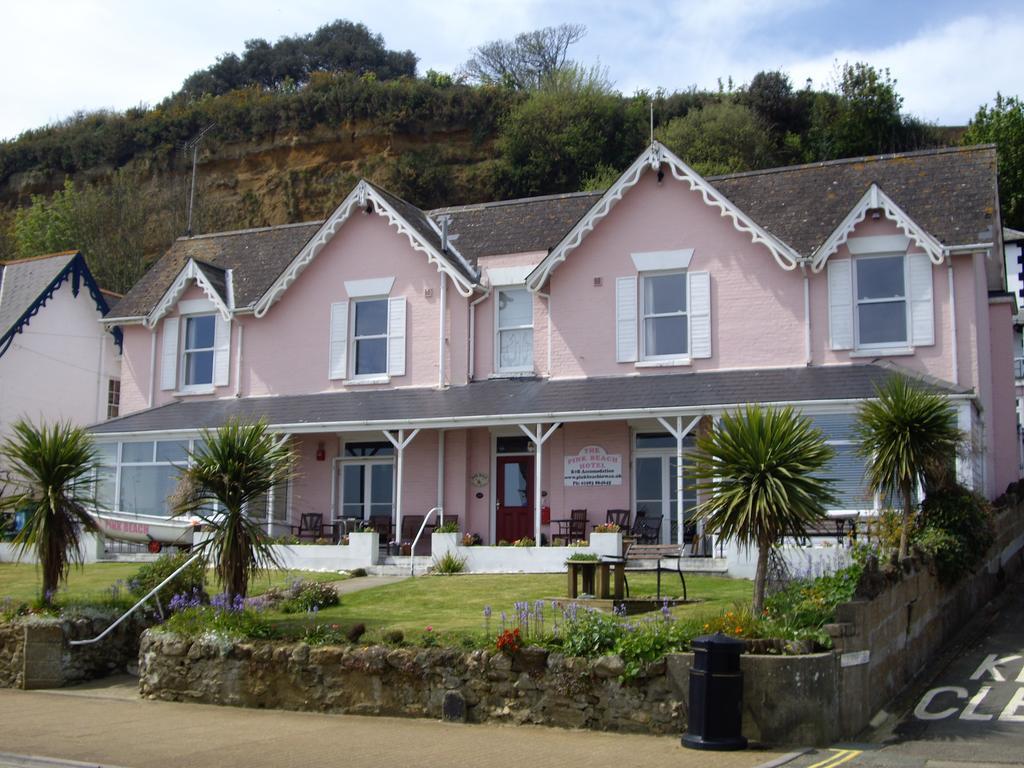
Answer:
[988,301,1020,495]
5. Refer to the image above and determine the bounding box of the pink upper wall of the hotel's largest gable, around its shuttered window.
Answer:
[550,171,804,378]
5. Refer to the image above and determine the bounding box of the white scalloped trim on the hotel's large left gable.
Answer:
[254,181,473,317]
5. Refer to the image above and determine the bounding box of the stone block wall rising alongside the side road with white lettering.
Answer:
[828,505,1024,737]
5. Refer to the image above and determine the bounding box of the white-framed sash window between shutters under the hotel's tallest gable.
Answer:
[640,271,689,360]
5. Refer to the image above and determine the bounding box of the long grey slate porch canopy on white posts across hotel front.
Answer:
[90,362,973,542]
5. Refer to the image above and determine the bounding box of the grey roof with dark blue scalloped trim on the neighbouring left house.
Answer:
[0,251,121,356]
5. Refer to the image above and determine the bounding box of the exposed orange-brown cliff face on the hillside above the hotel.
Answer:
[0,124,496,231]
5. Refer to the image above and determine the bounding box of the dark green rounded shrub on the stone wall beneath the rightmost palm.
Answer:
[913,485,994,585]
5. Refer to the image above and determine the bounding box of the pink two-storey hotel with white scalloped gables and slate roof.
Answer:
[92,142,1019,544]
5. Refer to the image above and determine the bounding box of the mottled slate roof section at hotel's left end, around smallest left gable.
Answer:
[111,221,323,321]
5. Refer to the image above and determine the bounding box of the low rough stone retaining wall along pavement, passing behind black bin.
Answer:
[139,631,837,743]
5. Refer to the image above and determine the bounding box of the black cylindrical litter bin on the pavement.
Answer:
[683,632,746,751]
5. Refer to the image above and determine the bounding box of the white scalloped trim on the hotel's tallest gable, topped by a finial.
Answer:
[526,141,801,292]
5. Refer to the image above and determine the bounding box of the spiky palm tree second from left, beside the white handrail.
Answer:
[173,420,295,599]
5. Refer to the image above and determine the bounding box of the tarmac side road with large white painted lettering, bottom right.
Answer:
[791,578,1024,768]
